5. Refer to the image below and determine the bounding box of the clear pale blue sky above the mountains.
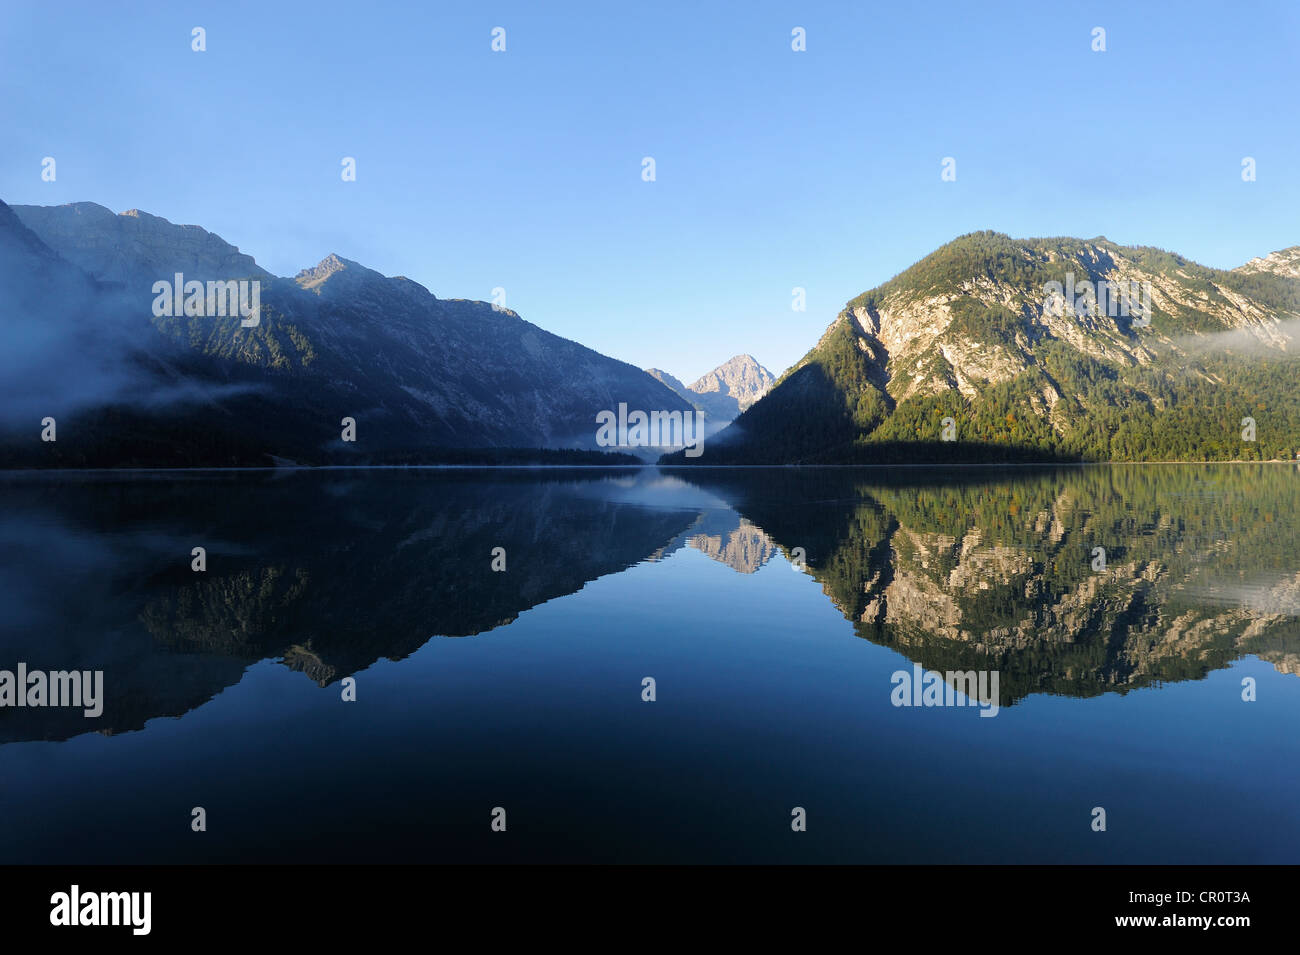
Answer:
[0,0,1300,382]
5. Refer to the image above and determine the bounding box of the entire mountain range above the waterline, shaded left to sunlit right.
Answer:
[0,203,1300,468]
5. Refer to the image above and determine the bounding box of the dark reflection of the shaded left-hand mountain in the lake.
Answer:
[0,470,699,741]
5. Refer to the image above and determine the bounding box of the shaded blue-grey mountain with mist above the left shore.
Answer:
[0,203,690,466]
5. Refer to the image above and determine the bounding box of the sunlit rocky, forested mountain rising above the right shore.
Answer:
[666,231,1300,464]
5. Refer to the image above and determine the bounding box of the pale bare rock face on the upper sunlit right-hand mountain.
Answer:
[842,239,1300,407]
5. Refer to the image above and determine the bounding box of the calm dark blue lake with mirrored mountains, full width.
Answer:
[0,465,1300,863]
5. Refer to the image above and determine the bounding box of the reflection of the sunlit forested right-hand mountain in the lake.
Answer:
[689,465,1300,704]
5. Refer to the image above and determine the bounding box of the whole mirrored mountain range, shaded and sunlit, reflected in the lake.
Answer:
[0,465,1300,742]
